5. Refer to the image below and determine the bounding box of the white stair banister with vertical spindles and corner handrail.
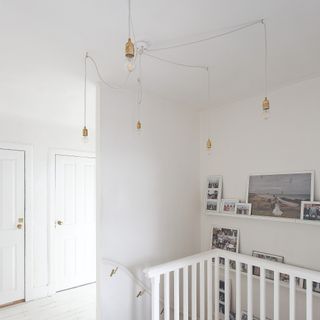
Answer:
[145,249,320,320]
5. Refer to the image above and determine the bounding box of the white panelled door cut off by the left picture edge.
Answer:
[0,149,25,306]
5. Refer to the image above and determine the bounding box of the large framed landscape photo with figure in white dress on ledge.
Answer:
[247,171,314,219]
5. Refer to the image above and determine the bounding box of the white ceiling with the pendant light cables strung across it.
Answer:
[0,0,320,124]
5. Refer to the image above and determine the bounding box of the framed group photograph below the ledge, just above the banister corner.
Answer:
[211,226,239,252]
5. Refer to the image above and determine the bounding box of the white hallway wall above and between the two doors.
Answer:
[0,113,95,298]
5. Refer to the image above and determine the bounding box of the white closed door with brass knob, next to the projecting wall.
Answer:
[55,155,96,291]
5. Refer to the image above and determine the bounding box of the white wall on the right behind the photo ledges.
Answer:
[201,78,320,319]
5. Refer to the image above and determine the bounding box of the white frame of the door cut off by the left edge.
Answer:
[0,142,33,301]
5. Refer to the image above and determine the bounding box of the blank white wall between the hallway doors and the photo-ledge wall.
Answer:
[98,88,200,319]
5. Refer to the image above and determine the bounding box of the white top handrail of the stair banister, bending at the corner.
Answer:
[144,249,320,283]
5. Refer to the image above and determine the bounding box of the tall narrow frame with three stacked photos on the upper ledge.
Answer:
[205,176,222,214]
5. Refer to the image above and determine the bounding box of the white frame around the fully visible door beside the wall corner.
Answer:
[48,149,97,295]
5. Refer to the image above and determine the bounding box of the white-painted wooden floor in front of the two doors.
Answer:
[0,284,96,320]
